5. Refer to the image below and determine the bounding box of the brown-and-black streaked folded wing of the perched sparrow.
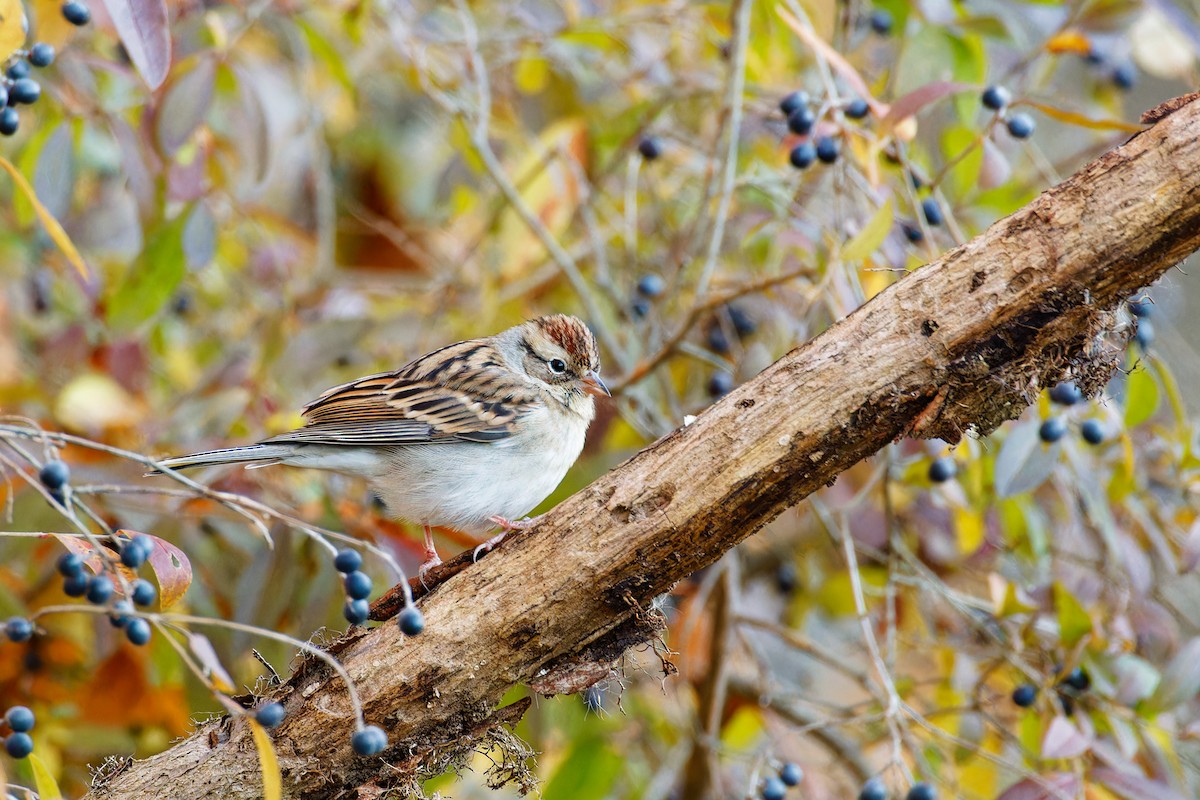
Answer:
[266,341,541,446]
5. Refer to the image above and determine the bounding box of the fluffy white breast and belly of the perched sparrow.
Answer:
[371,408,588,534]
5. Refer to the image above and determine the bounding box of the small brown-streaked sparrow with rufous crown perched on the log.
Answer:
[151,314,610,576]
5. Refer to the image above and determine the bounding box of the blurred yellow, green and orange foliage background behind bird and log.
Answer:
[0,0,1200,800]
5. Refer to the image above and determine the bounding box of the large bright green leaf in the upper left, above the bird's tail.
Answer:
[108,212,188,331]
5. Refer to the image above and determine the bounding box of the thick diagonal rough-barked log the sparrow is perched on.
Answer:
[92,97,1200,800]
